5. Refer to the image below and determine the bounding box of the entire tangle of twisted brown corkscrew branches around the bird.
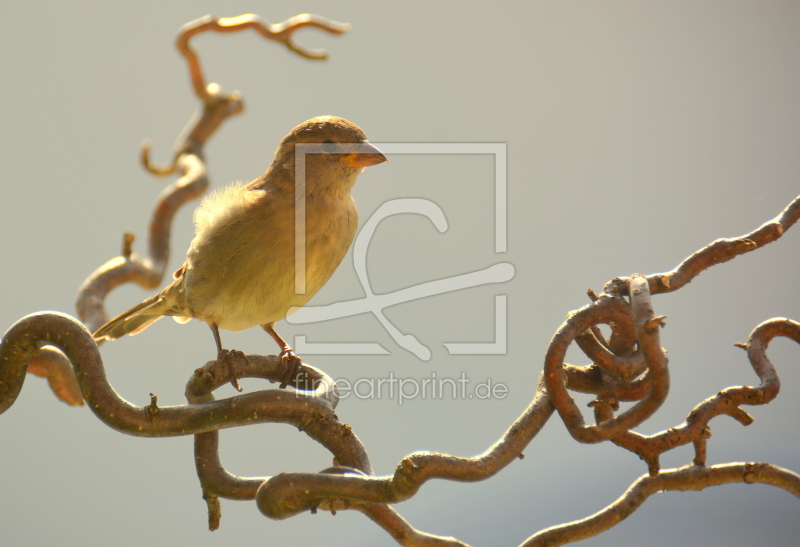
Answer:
[0,14,800,546]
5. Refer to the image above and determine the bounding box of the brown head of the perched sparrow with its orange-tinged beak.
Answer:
[271,116,388,194]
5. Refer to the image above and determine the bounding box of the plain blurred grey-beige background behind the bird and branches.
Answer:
[0,0,800,546]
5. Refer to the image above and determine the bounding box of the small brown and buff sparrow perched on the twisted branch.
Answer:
[94,116,387,391]
